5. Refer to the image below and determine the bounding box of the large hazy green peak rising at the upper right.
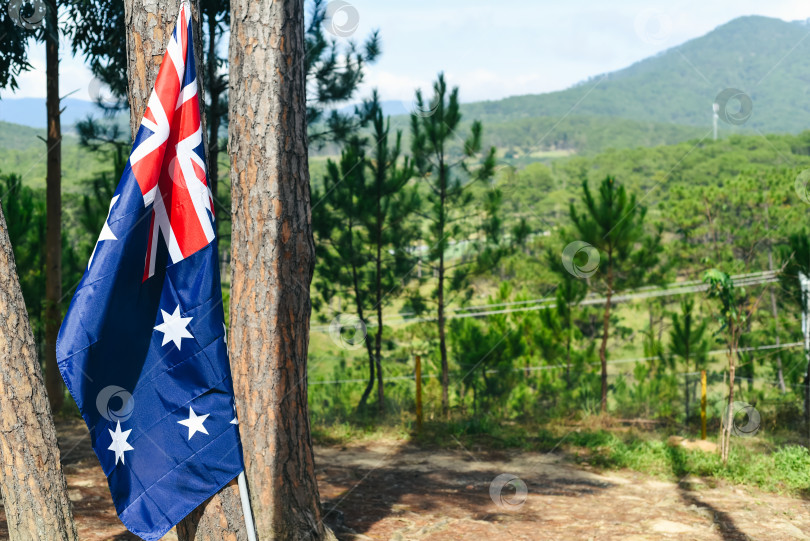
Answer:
[463,16,810,133]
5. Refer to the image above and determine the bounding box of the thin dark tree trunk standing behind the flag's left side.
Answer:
[45,0,65,413]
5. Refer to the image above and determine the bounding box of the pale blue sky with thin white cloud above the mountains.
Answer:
[0,0,810,102]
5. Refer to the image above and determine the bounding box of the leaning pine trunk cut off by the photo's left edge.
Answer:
[0,205,78,541]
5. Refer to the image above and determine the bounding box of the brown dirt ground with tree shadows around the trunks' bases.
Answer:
[0,422,810,541]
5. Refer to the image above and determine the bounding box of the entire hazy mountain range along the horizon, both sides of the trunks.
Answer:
[6,16,810,154]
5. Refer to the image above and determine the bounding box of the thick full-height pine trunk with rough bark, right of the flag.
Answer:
[229,0,334,541]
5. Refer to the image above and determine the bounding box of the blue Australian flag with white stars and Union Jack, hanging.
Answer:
[56,3,243,541]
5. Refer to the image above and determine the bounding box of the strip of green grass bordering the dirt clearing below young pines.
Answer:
[313,415,810,497]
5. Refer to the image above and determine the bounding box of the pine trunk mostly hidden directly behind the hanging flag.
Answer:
[124,0,247,541]
